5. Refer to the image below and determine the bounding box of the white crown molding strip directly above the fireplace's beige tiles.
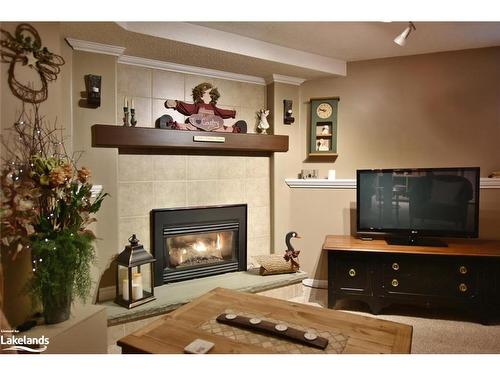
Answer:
[118,55,266,85]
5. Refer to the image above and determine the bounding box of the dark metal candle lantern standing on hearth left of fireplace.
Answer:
[115,234,156,309]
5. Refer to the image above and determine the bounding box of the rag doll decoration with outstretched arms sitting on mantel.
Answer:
[165,82,247,133]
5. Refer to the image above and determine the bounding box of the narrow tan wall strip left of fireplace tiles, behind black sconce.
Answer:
[72,51,118,300]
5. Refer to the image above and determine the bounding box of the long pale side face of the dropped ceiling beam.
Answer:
[117,22,347,76]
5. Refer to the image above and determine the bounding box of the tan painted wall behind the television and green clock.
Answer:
[287,47,500,278]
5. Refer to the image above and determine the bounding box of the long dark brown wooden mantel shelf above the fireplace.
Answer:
[92,124,288,155]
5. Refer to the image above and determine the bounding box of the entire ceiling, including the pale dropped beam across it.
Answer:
[61,22,500,80]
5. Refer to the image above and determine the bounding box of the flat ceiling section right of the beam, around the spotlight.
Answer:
[195,22,500,61]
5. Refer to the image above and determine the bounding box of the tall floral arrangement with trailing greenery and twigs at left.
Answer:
[0,105,107,324]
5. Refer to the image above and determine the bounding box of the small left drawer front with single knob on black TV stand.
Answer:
[332,255,370,294]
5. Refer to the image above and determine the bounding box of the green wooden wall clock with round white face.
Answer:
[309,97,340,156]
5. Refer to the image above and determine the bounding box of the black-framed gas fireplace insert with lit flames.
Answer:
[151,204,247,286]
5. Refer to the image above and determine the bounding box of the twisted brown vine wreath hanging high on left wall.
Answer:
[0,23,64,103]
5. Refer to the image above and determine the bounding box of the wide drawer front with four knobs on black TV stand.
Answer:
[382,255,480,298]
